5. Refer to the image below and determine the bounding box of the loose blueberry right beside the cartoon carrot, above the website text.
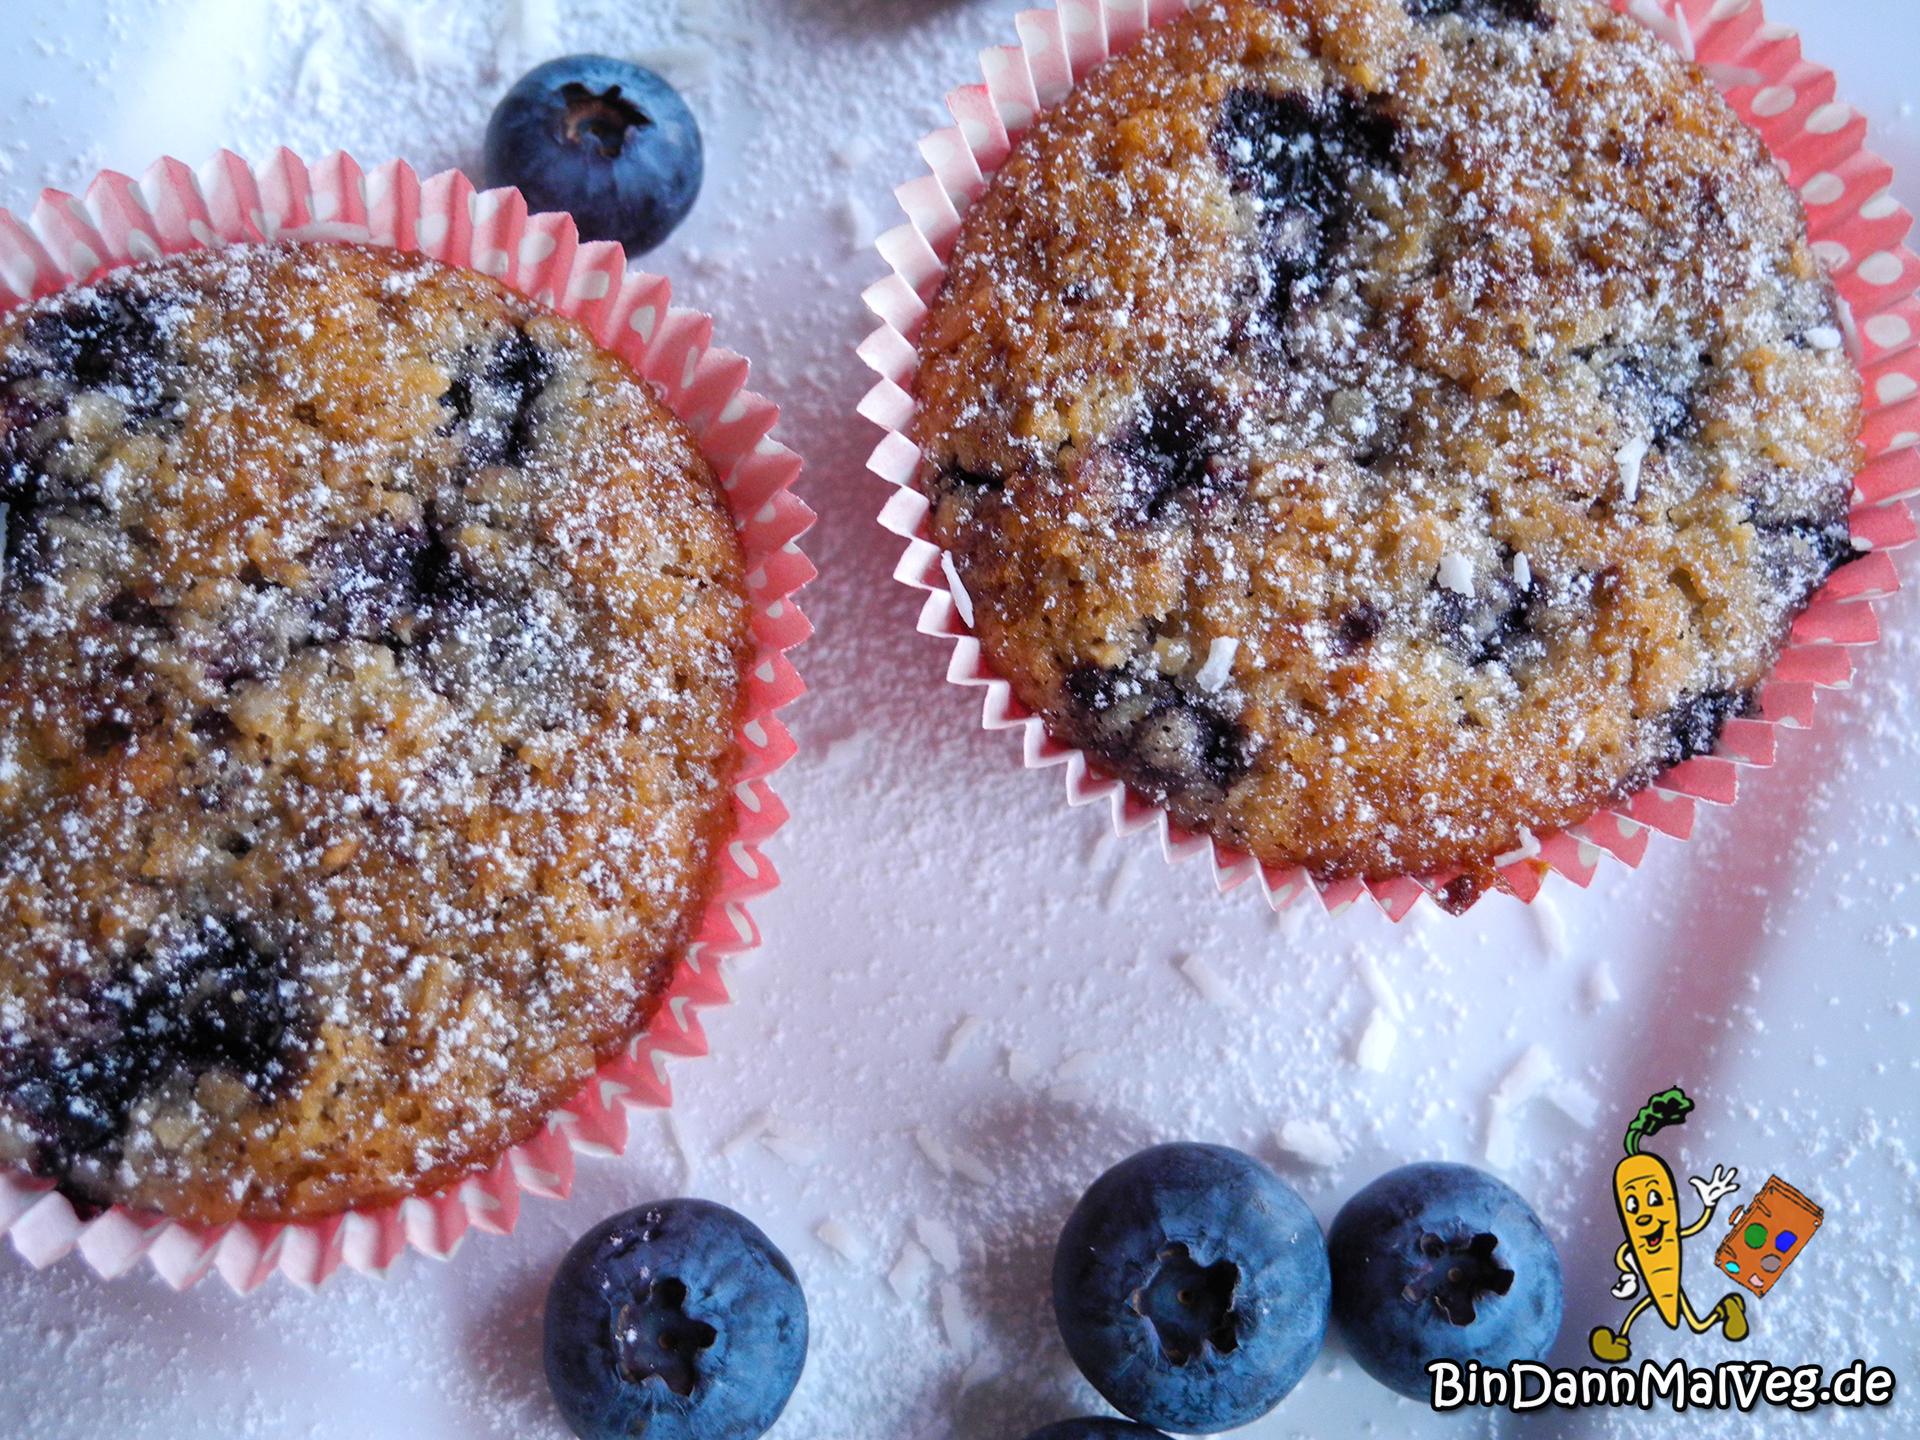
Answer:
[1327,1164,1563,1400]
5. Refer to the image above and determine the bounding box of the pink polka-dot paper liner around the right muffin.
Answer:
[858,0,1920,920]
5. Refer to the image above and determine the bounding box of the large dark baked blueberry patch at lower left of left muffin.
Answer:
[0,916,317,1173]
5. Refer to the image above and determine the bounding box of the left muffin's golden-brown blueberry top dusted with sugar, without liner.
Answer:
[0,246,749,1223]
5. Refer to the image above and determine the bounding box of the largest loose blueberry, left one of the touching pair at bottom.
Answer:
[1054,1144,1329,1434]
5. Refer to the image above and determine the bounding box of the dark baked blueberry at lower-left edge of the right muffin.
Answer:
[1066,660,1250,801]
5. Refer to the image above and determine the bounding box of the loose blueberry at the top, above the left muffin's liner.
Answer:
[482,56,703,255]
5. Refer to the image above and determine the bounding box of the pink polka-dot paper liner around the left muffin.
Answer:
[0,150,814,1292]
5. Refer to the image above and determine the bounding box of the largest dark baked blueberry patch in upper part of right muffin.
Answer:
[1213,88,1396,324]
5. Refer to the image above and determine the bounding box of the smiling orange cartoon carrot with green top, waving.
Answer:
[1586,1087,1747,1363]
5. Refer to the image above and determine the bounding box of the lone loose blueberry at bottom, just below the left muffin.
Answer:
[545,1200,806,1440]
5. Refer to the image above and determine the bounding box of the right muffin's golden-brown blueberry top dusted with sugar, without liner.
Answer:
[912,0,1860,908]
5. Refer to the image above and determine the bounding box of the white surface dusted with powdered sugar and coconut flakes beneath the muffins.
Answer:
[0,0,1920,1440]
